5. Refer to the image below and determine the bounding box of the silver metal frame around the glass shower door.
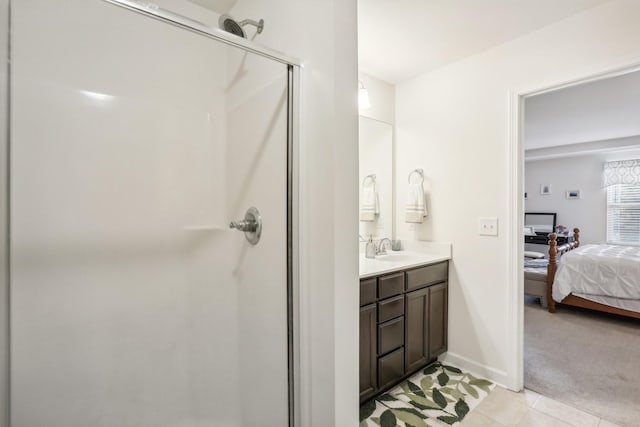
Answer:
[5,0,302,427]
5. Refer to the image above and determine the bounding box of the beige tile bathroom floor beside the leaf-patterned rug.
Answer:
[460,387,617,427]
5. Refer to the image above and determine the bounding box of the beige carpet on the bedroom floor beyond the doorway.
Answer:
[524,298,640,426]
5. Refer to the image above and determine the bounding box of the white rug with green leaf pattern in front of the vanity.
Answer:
[360,362,495,427]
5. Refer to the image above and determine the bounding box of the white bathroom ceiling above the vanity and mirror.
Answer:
[358,0,609,83]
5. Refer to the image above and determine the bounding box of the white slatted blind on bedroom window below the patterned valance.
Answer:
[607,184,640,245]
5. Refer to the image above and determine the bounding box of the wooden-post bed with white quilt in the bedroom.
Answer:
[544,229,640,319]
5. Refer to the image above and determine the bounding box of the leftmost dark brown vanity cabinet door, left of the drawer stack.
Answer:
[360,304,378,402]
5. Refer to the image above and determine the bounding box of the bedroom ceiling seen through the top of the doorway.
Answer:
[525,71,640,150]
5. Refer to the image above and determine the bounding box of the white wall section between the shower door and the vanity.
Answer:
[232,0,359,427]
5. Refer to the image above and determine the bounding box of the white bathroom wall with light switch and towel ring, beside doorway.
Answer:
[396,0,640,387]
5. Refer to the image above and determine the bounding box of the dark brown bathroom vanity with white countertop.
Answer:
[360,253,449,402]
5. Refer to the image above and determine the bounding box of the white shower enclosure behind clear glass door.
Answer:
[9,0,299,427]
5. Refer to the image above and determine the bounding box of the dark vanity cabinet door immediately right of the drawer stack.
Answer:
[404,288,429,373]
